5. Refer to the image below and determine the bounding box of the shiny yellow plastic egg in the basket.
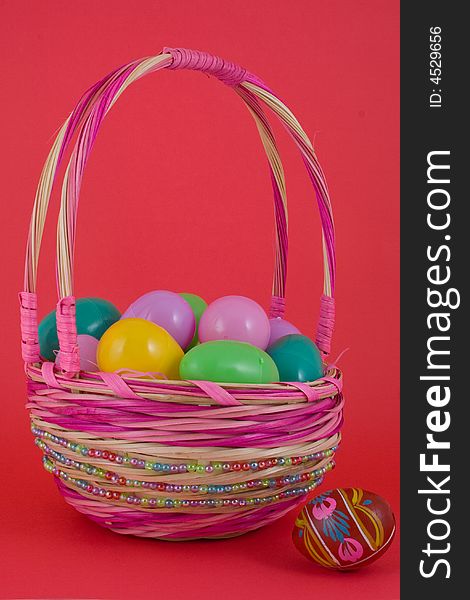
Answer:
[97,319,184,379]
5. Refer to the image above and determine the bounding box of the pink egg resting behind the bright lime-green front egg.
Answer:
[199,296,271,350]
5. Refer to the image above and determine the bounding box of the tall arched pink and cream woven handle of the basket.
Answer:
[20,48,335,375]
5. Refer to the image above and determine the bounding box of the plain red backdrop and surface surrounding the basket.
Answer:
[0,0,399,600]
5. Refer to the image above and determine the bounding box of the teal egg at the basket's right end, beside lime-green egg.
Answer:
[266,333,323,381]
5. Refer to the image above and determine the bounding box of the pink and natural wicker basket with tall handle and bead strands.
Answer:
[20,48,343,540]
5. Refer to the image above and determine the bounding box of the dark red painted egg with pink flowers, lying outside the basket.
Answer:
[292,488,395,570]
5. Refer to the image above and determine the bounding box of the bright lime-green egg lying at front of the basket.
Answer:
[180,340,279,383]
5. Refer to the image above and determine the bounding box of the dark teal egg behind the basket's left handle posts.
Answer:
[38,298,121,360]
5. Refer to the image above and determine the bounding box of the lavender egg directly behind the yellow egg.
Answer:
[121,290,196,349]
